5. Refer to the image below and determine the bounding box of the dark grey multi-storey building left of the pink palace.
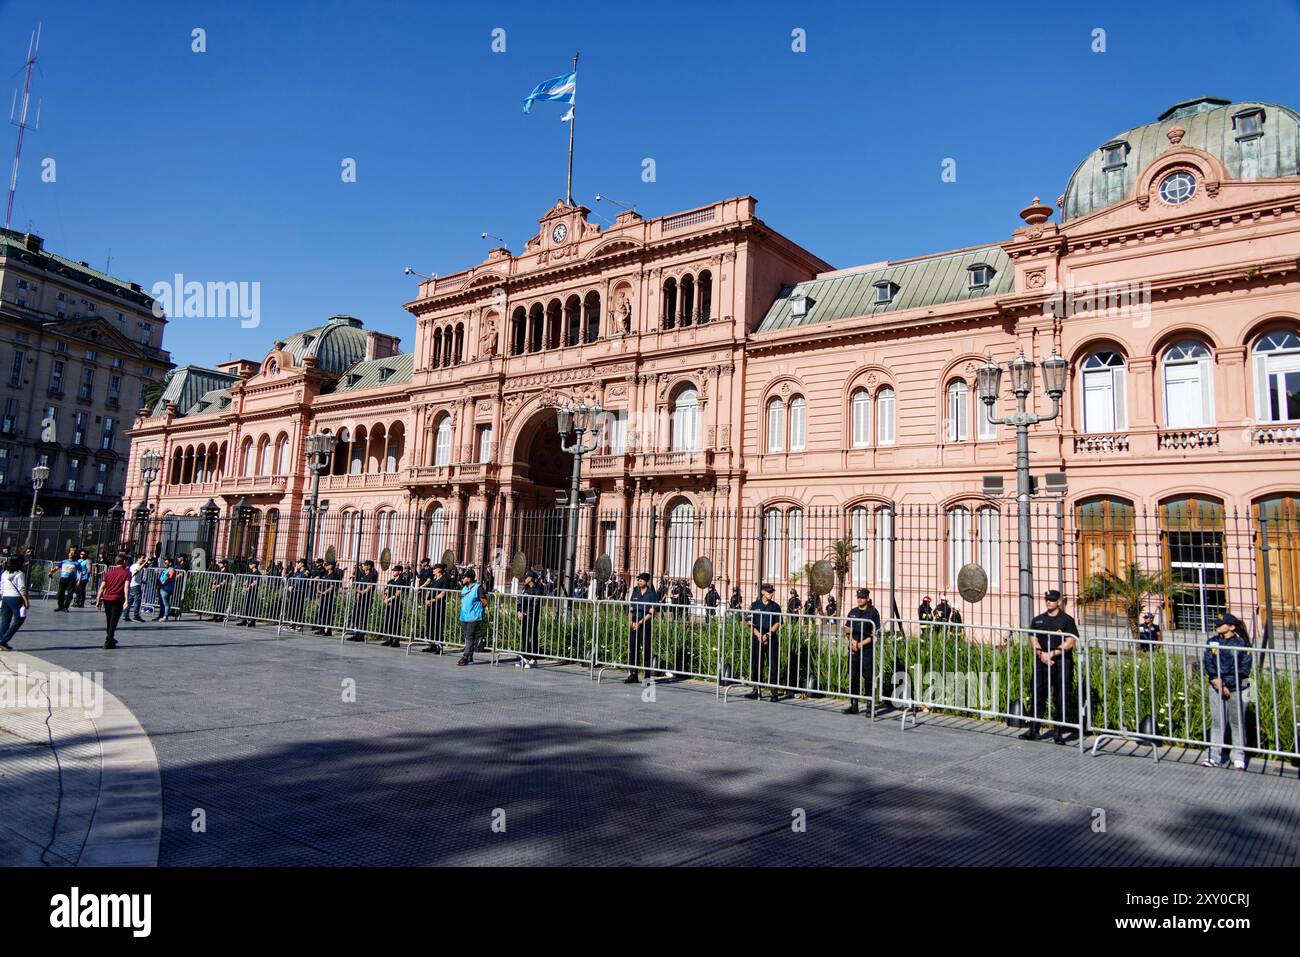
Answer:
[0,229,172,516]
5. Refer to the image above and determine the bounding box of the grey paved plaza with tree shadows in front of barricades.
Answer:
[0,602,1300,866]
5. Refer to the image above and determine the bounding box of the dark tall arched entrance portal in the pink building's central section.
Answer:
[510,408,573,570]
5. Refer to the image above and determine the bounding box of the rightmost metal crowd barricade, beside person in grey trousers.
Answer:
[1084,636,1300,761]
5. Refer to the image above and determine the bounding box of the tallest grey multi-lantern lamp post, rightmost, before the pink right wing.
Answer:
[975,347,1069,628]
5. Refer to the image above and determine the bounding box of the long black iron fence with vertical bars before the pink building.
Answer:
[0,499,1300,648]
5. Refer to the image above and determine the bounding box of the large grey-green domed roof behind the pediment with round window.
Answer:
[1061,96,1300,222]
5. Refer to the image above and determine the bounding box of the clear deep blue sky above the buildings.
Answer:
[0,0,1300,364]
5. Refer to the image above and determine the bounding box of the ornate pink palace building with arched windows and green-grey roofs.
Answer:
[125,99,1300,639]
